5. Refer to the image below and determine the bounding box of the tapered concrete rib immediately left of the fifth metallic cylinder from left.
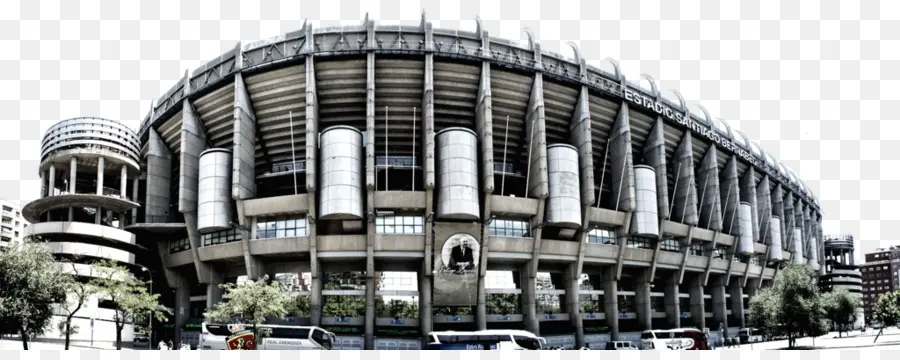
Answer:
[601,101,636,280]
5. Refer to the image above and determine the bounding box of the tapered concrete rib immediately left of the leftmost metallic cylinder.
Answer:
[178,100,212,284]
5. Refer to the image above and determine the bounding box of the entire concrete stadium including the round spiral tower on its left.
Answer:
[26,17,825,349]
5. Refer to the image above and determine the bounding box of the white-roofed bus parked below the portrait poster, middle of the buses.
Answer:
[427,330,546,350]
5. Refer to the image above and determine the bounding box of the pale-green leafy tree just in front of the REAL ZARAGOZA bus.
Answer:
[203,275,298,342]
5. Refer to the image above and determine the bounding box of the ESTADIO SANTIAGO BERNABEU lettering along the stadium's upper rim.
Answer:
[623,88,759,165]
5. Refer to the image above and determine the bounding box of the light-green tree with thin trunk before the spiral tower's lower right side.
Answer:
[92,260,166,350]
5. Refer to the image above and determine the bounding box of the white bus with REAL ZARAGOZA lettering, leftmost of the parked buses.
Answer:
[198,323,335,350]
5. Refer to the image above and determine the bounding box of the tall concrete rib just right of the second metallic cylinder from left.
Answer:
[365,17,375,349]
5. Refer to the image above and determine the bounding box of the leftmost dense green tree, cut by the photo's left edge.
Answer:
[0,239,68,350]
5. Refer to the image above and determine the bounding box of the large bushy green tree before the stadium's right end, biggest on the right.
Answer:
[750,264,825,348]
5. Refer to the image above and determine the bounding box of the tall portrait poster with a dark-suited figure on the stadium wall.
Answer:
[432,233,481,306]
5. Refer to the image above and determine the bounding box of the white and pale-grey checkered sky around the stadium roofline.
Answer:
[0,0,888,264]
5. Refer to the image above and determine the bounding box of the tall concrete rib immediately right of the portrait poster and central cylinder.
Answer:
[472,26,494,330]
